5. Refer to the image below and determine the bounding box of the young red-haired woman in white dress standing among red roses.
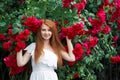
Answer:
[17,19,75,80]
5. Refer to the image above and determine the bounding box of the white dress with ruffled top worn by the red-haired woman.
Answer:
[24,43,58,80]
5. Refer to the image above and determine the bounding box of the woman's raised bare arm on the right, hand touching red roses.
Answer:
[62,37,75,61]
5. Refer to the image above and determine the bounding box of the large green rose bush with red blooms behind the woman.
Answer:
[0,0,120,80]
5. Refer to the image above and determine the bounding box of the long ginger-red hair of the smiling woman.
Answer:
[34,19,65,66]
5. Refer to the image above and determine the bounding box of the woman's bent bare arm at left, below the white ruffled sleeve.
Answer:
[16,50,31,67]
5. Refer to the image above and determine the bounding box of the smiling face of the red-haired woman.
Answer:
[41,24,52,40]
